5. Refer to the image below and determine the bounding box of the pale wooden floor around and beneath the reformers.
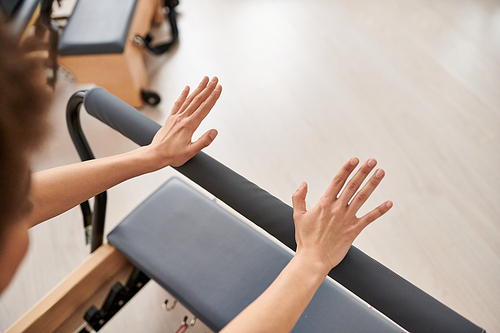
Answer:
[0,0,500,332]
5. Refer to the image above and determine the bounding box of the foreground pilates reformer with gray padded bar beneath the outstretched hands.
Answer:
[7,88,485,332]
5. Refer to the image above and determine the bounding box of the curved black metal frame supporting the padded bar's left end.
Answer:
[66,90,107,252]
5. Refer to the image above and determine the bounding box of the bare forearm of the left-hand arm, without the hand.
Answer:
[29,148,154,226]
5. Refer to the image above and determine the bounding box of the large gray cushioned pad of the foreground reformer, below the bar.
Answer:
[108,178,401,332]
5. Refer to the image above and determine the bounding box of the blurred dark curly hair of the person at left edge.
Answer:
[0,15,50,246]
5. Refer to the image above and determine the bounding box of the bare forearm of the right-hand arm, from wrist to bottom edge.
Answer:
[221,255,328,333]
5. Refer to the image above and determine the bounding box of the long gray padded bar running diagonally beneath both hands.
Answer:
[84,88,483,333]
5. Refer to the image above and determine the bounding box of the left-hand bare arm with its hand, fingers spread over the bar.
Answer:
[28,77,222,226]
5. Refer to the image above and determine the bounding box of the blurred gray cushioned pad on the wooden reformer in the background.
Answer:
[59,0,137,56]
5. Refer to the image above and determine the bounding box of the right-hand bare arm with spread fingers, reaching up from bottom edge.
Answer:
[221,158,392,333]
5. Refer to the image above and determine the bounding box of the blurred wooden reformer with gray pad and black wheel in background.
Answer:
[58,0,178,107]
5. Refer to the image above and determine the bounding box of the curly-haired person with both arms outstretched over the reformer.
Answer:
[0,22,392,332]
